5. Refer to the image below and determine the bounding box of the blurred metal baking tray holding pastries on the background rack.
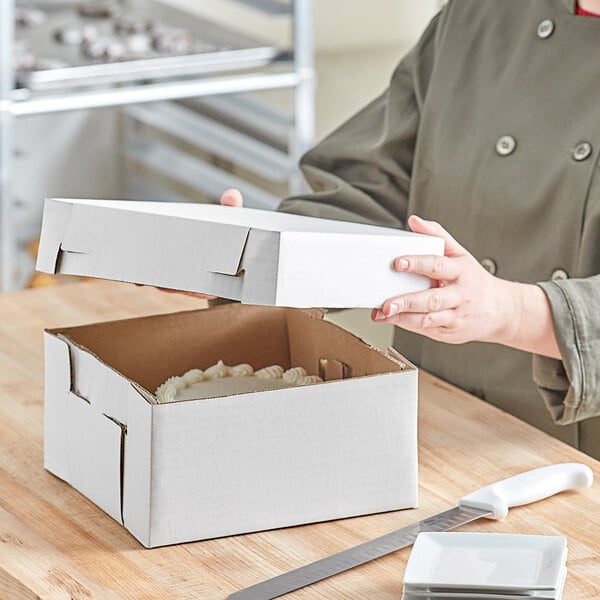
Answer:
[16,0,289,91]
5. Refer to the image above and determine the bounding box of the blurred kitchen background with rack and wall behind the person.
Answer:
[0,0,441,346]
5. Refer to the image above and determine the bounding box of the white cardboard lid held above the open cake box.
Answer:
[37,198,444,308]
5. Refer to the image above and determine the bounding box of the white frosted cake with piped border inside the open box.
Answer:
[155,360,322,404]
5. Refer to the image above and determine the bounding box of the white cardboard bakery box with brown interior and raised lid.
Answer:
[38,200,443,547]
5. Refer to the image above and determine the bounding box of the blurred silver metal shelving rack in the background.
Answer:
[0,0,314,291]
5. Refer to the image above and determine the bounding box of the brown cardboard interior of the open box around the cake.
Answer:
[51,304,412,392]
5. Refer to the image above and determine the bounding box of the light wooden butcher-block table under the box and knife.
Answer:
[0,282,600,600]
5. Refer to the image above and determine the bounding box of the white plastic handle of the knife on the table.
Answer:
[458,463,594,519]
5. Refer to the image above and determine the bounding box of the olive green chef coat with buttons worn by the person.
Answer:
[280,0,600,458]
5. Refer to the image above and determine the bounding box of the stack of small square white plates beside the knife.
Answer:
[403,533,567,600]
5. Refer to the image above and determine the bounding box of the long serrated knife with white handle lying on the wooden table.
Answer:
[227,463,593,600]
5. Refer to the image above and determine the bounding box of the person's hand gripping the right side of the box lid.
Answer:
[371,216,519,344]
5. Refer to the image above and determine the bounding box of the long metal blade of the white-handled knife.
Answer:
[227,506,491,600]
